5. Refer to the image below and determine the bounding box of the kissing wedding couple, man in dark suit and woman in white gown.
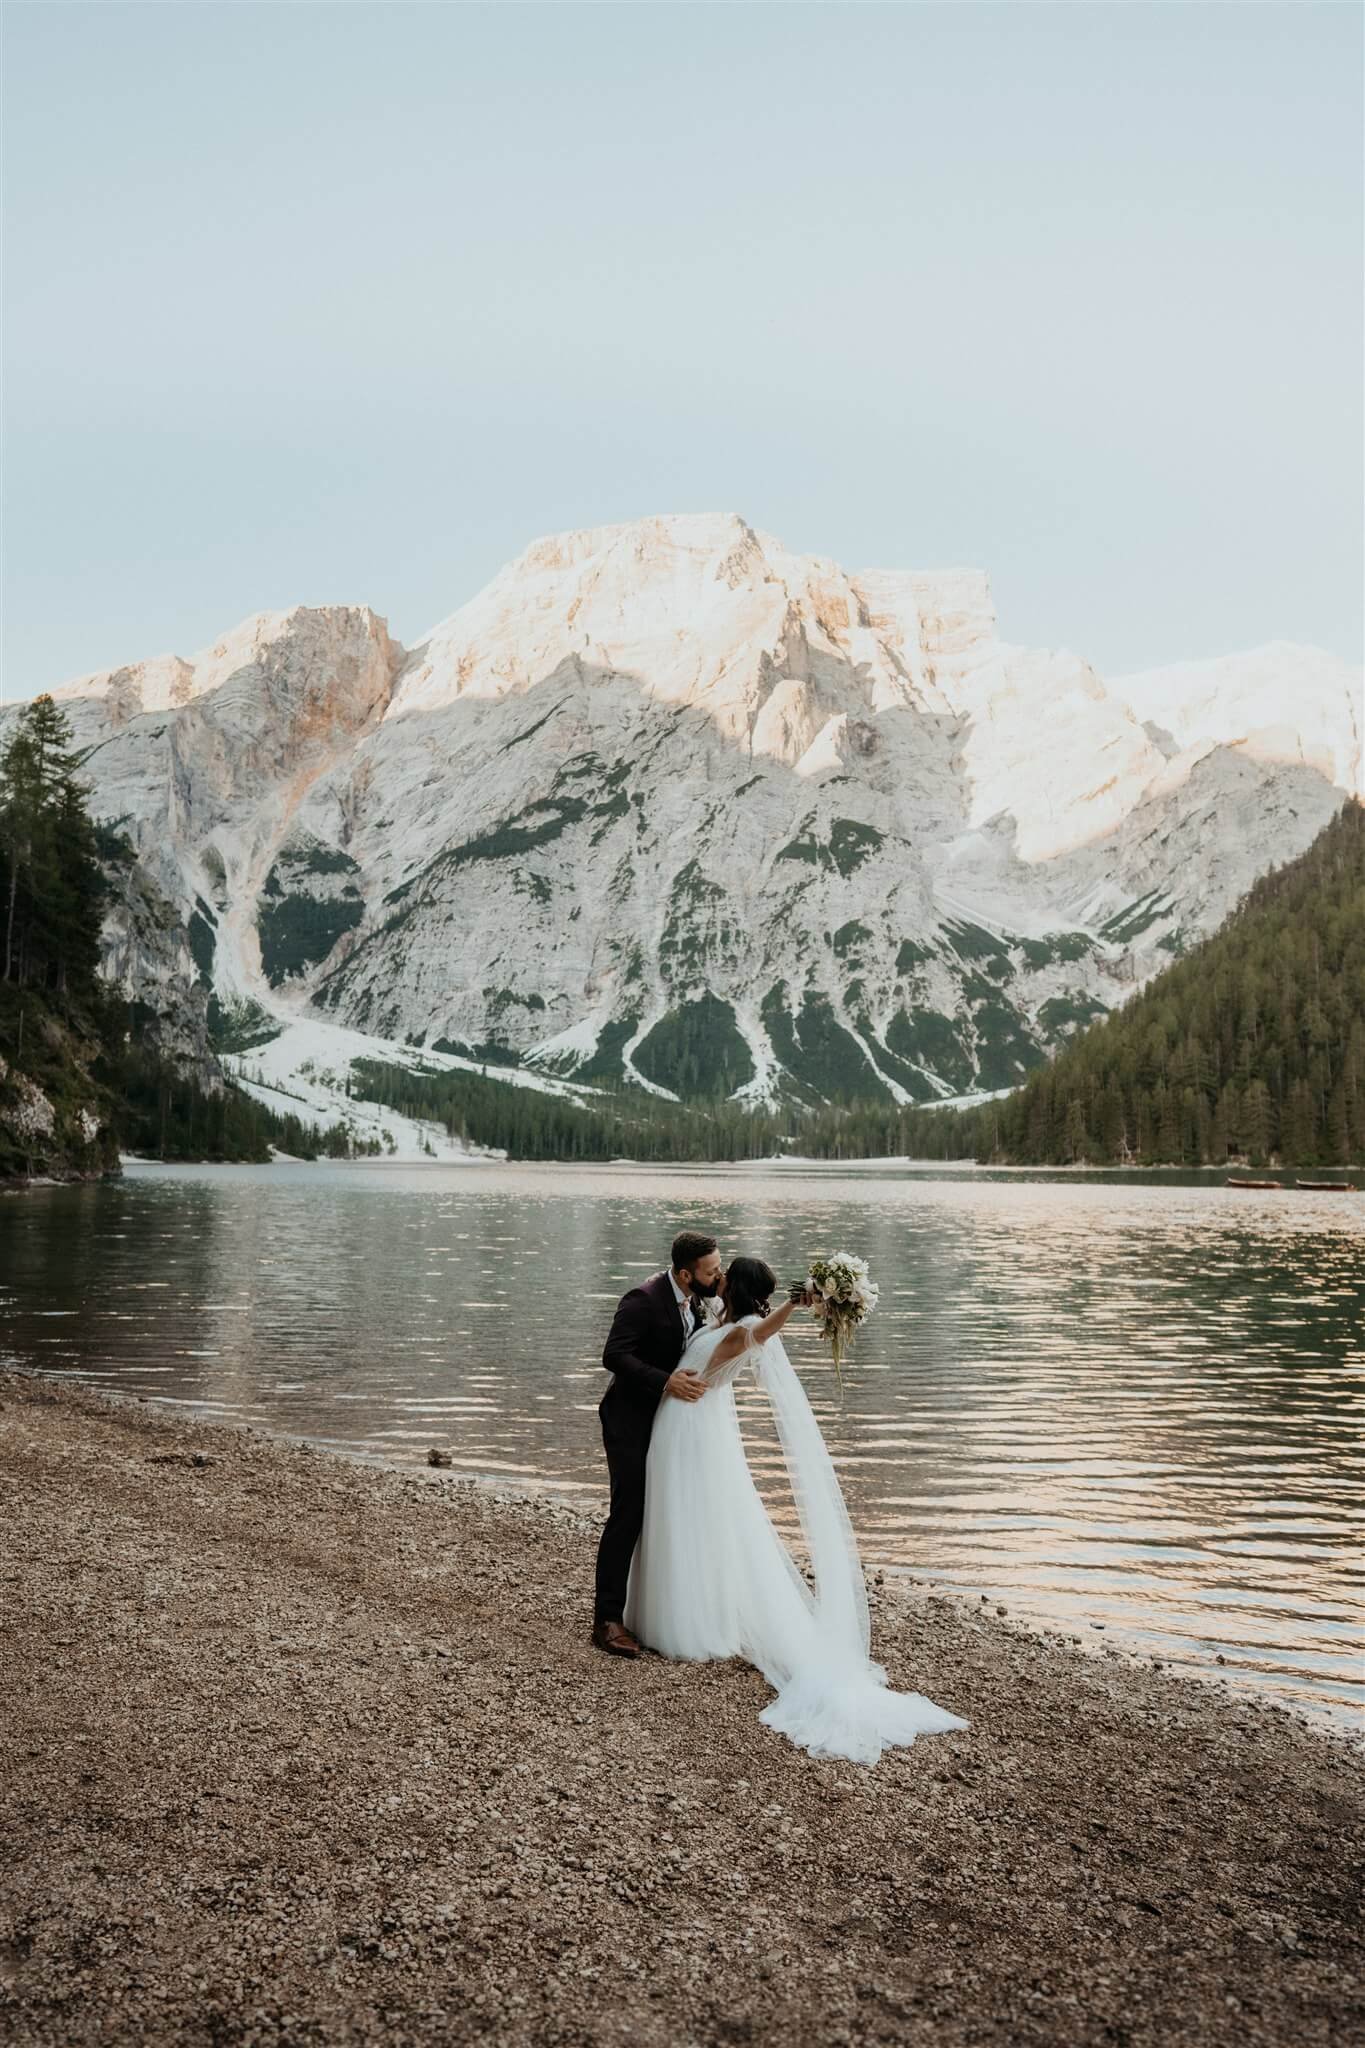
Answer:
[591,1231,970,1763]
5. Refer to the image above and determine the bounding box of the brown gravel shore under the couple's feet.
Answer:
[0,1372,1365,2048]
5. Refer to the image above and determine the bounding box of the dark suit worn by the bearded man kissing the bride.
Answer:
[593,1272,700,1622]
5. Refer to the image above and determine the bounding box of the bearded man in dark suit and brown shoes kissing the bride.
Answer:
[591,1231,720,1657]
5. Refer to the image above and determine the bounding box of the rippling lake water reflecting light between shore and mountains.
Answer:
[0,1165,1365,1726]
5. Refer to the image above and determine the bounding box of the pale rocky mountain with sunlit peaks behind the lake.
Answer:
[26,514,1361,1108]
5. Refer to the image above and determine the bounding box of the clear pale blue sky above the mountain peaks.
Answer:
[4,0,1363,694]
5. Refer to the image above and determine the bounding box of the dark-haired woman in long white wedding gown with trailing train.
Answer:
[626,1257,970,1763]
